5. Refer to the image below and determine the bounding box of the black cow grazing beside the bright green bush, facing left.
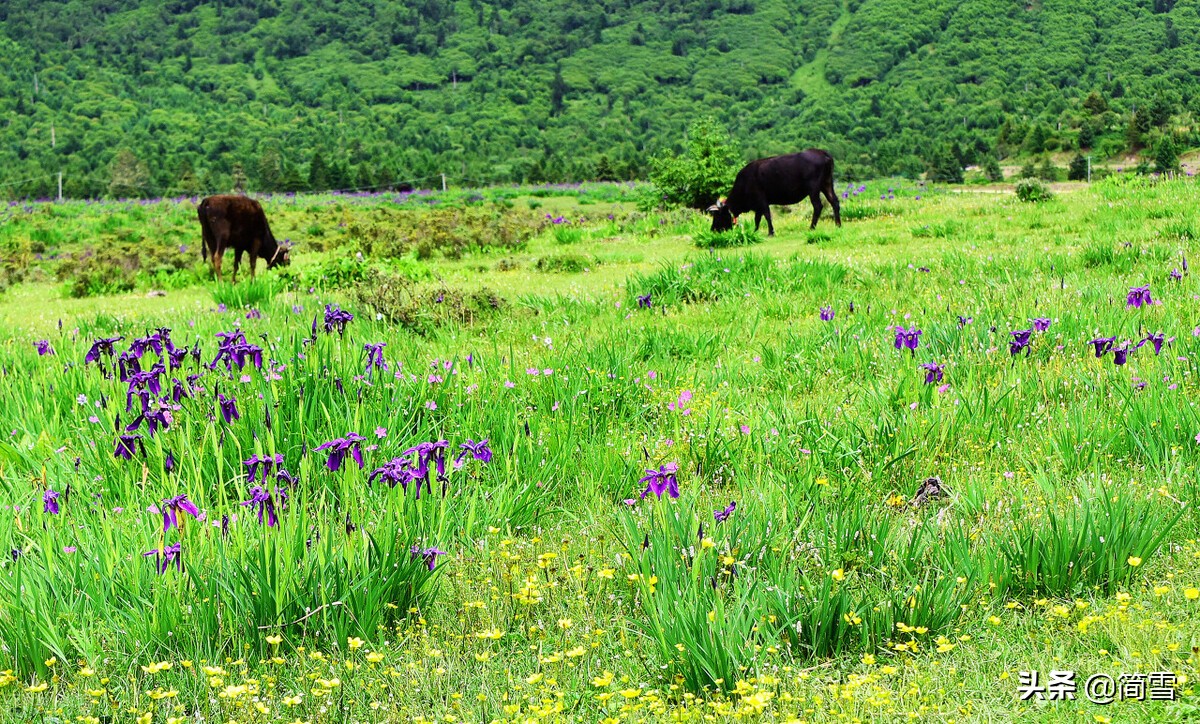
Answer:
[708,149,841,237]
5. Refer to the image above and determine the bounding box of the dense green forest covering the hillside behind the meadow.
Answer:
[0,0,1200,197]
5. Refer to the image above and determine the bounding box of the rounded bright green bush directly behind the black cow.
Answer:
[650,118,740,209]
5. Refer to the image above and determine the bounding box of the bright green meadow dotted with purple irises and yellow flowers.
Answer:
[0,179,1200,724]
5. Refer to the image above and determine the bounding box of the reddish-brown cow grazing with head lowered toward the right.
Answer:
[197,195,292,281]
